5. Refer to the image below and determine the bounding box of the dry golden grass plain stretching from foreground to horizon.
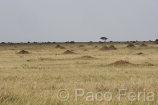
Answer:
[0,42,158,105]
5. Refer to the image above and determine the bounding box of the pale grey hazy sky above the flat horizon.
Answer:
[0,0,158,42]
